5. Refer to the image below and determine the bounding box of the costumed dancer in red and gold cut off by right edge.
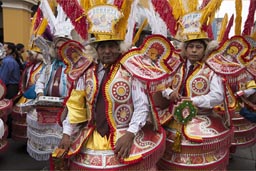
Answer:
[225,1,256,150]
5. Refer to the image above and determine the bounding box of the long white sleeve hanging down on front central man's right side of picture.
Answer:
[127,80,149,134]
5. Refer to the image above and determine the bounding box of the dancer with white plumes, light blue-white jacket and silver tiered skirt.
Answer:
[27,1,71,160]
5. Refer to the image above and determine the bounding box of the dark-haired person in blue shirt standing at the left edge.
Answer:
[0,42,20,99]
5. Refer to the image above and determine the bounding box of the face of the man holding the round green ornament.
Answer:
[186,41,205,64]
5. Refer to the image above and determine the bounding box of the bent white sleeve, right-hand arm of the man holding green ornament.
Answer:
[191,73,224,108]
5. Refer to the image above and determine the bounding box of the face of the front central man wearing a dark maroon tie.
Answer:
[97,41,121,65]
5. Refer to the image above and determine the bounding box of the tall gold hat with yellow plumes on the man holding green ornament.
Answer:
[163,0,222,42]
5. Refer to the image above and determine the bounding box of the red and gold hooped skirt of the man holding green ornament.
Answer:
[158,114,233,171]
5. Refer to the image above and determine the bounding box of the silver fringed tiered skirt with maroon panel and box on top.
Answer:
[26,96,63,161]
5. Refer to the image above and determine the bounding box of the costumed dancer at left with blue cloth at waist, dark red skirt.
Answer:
[12,3,52,142]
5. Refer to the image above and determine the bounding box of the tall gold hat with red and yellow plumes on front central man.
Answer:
[57,0,133,42]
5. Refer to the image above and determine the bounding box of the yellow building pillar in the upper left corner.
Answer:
[0,0,39,47]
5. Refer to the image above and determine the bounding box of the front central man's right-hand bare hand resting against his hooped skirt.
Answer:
[114,131,135,159]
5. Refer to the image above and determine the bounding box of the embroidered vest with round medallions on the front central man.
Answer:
[84,65,133,128]
